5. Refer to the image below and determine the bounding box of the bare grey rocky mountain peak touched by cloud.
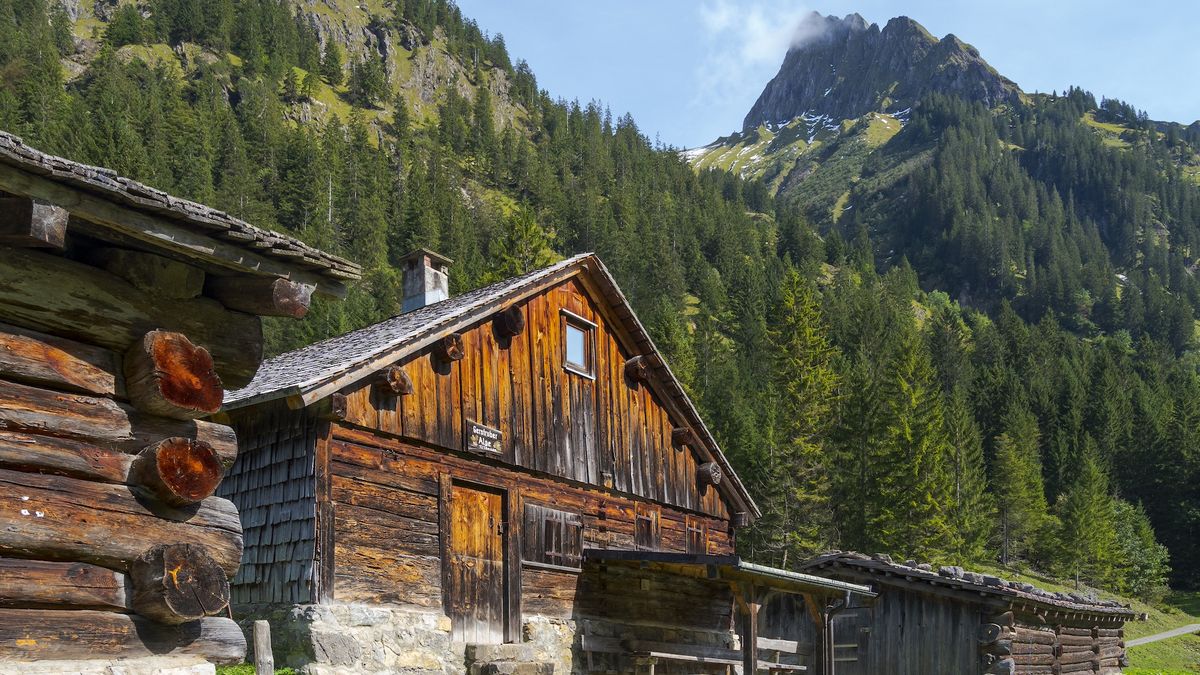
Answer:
[743,12,1020,131]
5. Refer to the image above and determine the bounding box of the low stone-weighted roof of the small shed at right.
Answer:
[800,551,1135,620]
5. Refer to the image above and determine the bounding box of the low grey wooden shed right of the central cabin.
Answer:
[802,552,1134,675]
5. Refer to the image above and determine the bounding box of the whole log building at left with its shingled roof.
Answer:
[0,132,359,675]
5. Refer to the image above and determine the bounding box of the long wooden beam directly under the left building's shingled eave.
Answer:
[0,163,346,298]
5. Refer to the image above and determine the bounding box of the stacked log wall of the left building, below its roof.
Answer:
[0,239,272,663]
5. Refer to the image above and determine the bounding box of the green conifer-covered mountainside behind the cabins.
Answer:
[0,0,1200,610]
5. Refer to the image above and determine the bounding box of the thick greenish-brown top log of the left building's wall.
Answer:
[0,246,263,388]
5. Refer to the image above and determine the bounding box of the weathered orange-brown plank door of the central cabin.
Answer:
[446,485,505,645]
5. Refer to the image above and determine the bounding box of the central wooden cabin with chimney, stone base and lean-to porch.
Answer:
[220,250,871,675]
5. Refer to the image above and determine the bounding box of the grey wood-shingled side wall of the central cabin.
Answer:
[217,401,320,604]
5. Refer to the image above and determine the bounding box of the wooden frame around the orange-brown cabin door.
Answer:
[438,472,522,643]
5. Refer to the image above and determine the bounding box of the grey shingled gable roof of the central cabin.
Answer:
[224,253,761,518]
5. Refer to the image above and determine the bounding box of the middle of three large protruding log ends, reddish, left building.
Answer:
[130,437,224,507]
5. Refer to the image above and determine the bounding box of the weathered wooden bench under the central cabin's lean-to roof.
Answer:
[581,633,808,675]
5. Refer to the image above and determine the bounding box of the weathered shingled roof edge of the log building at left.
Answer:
[0,131,361,294]
